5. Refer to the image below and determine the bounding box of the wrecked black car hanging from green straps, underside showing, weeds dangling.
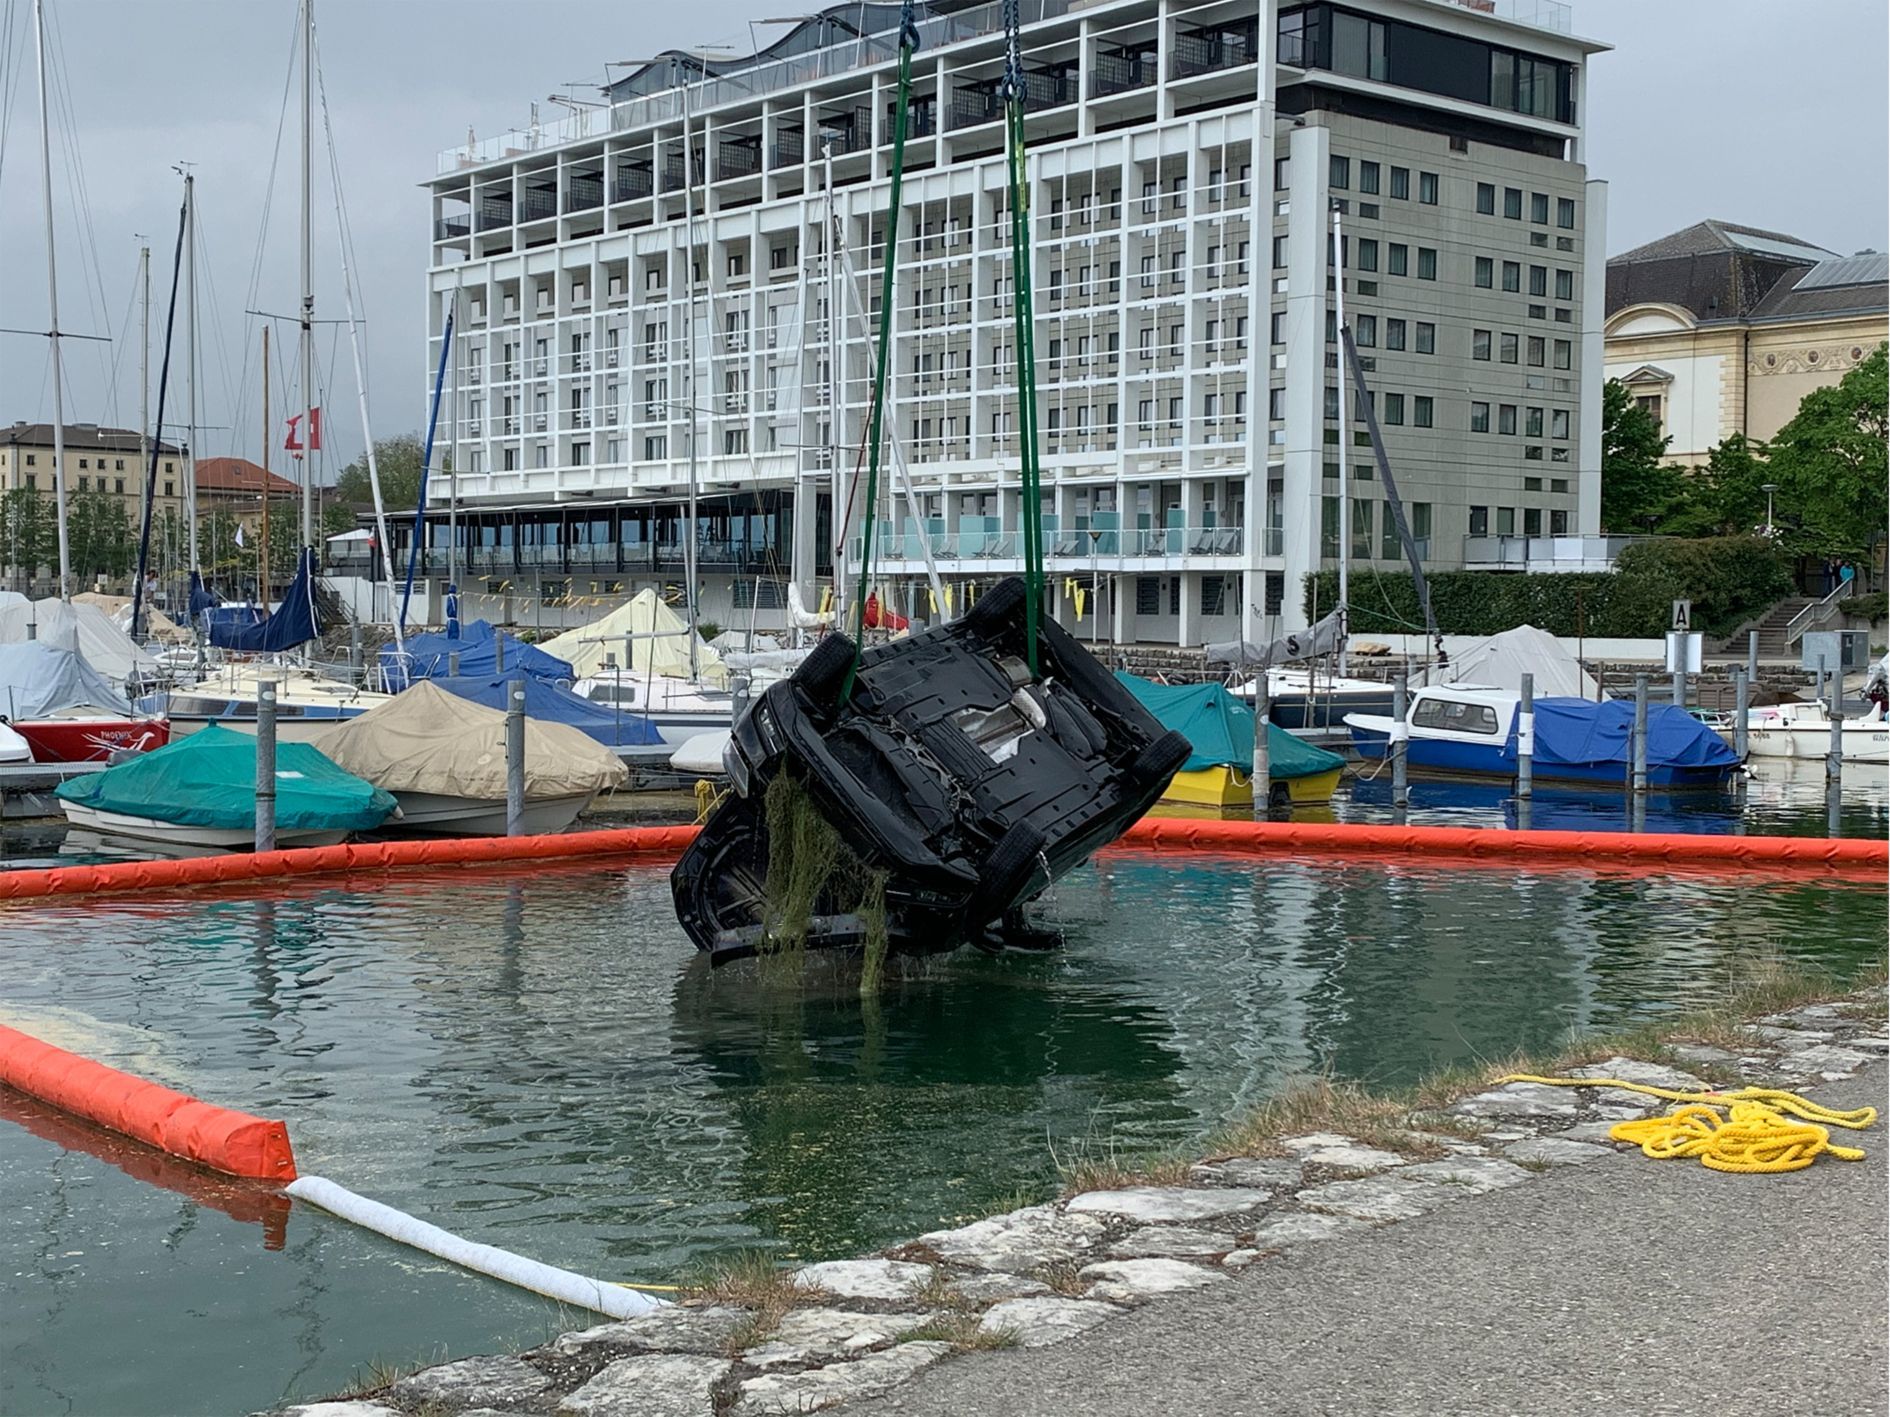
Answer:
[671,578,1191,964]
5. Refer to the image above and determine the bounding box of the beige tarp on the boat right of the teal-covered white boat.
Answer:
[314,680,629,801]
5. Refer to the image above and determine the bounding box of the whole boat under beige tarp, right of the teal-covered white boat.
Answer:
[312,680,629,837]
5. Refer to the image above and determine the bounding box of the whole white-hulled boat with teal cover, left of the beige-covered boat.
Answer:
[53,724,399,850]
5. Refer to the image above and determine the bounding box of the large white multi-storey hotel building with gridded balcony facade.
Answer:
[406,0,1605,644]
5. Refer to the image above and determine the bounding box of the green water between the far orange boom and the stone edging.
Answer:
[0,854,1884,1413]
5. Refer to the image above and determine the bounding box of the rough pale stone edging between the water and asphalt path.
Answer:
[262,1005,1890,1417]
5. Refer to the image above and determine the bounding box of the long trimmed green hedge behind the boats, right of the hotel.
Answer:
[1306,537,1792,639]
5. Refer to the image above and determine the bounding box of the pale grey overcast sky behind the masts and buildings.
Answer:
[0,0,1890,483]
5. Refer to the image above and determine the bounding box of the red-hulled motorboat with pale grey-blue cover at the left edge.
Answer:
[0,640,170,765]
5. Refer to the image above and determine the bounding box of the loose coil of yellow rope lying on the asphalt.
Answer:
[1497,1073,1877,1175]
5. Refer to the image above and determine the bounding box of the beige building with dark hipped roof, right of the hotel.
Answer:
[1603,221,1890,467]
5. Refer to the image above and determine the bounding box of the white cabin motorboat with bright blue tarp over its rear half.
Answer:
[1346,684,1739,788]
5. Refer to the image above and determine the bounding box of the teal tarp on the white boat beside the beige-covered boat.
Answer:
[55,724,395,831]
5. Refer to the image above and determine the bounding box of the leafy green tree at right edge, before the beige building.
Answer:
[1771,344,1890,557]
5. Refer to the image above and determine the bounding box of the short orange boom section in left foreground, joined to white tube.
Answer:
[0,1026,295,1185]
